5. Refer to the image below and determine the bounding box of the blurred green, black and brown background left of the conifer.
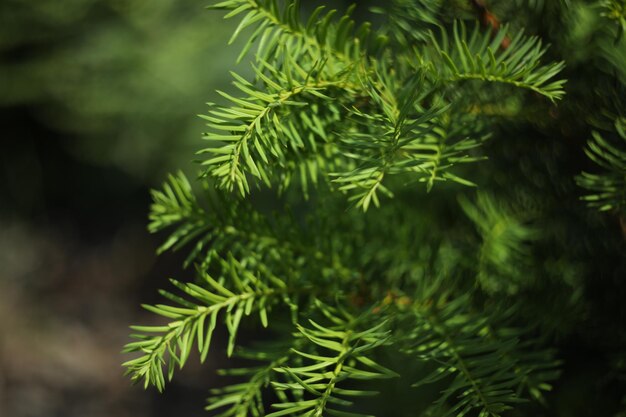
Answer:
[0,0,243,417]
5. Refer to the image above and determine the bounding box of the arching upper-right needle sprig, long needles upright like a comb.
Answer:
[425,22,565,101]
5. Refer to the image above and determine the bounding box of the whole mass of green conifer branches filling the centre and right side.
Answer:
[124,0,626,417]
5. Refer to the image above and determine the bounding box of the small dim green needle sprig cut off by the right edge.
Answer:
[576,118,626,211]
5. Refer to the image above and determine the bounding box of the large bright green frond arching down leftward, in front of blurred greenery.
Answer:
[198,58,351,195]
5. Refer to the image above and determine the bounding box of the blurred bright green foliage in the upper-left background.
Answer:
[0,0,236,179]
